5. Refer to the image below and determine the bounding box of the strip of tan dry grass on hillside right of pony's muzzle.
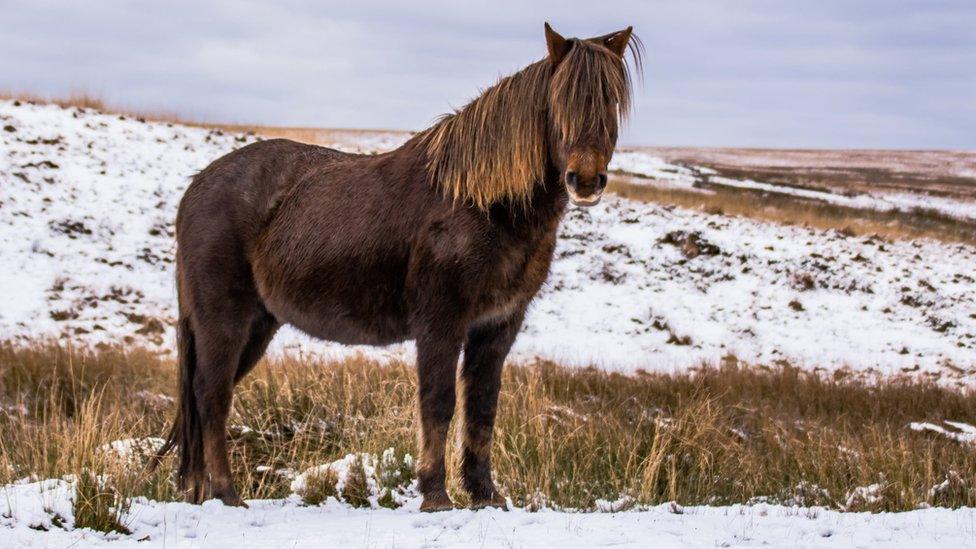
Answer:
[608,175,976,245]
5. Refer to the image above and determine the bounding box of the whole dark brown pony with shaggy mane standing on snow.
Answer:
[160,24,641,511]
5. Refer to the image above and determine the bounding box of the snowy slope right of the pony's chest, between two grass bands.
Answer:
[532,200,976,375]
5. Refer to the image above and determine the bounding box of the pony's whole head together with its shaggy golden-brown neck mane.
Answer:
[419,23,641,210]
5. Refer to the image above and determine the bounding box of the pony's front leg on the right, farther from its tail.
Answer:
[461,312,523,508]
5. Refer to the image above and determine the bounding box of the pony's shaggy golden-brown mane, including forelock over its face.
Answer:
[420,36,641,210]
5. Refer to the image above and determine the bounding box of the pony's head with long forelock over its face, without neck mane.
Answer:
[545,23,640,206]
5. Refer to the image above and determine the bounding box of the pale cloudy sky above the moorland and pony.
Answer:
[0,0,976,149]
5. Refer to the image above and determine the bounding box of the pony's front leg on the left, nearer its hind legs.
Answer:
[417,330,462,511]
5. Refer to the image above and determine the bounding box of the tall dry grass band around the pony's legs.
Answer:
[0,338,976,529]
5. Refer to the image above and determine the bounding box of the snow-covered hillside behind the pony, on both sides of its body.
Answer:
[0,101,976,384]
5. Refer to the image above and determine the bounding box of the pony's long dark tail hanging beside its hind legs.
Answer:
[152,307,203,491]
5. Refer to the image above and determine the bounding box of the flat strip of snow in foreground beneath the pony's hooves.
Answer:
[0,480,976,549]
